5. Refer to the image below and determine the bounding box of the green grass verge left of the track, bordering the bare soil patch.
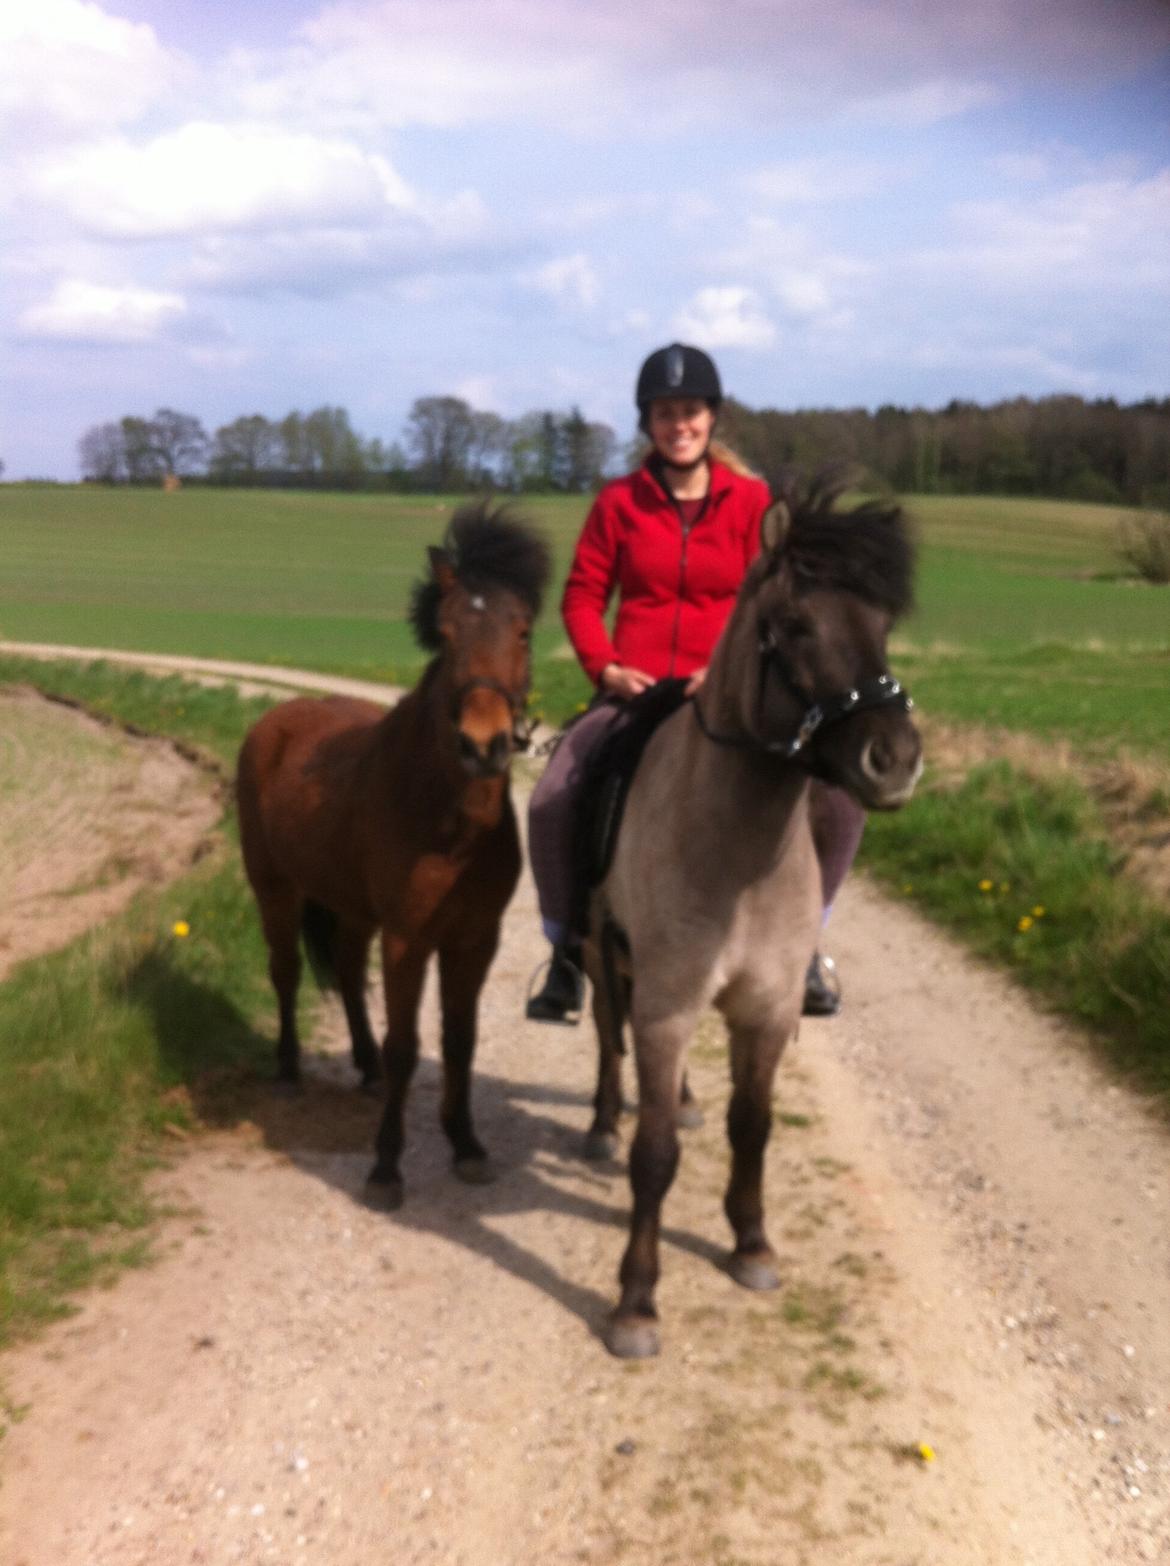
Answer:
[0,659,273,1344]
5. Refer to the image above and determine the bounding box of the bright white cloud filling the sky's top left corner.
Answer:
[0,0,183,135]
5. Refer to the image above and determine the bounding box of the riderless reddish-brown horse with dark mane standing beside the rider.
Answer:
[237,504,548,1207]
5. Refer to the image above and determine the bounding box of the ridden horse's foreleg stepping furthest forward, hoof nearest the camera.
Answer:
[606,1019,689,1359]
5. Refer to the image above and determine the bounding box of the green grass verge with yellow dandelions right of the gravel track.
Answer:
[861,761,1170,1096]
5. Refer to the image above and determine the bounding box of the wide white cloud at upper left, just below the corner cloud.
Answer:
[34,122,415,240]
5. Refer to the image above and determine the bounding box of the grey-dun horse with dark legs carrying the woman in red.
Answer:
[586,478,921,1358]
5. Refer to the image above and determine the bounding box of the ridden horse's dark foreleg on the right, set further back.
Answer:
[724,1024,788,1289]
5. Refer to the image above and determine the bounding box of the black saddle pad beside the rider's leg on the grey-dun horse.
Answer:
[573,680,686,930]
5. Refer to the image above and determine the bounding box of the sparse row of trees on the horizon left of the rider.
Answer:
[78,396,616,493]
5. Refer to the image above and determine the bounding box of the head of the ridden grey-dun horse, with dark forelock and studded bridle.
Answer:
[728,474,923,810]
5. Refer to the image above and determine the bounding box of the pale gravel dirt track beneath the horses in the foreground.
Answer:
[0,654,1170,1566]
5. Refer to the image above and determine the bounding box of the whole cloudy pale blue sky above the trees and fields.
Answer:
[0,0,1170,479]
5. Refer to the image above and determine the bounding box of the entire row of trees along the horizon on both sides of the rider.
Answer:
[78,396,1170,506]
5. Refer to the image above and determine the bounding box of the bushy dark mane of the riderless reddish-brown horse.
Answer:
[410,500,551,651]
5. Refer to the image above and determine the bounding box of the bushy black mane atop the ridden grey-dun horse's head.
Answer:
[777,467,915,615]
